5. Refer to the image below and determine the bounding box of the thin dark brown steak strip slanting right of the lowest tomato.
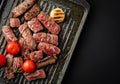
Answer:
[36,56,57,68]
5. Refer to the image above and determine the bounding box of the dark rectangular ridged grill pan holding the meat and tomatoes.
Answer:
[0,0,90,84]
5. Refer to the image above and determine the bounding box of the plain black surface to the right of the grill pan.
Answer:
[62,0,120,84]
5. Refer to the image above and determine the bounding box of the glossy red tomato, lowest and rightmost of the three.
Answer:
[22,60,35,73]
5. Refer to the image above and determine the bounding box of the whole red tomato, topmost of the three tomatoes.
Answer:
[6,42,20,55]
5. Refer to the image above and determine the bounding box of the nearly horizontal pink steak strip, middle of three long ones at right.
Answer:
[33,32,58,46]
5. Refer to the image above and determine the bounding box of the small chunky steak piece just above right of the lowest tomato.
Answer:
[29,50,43,62]
